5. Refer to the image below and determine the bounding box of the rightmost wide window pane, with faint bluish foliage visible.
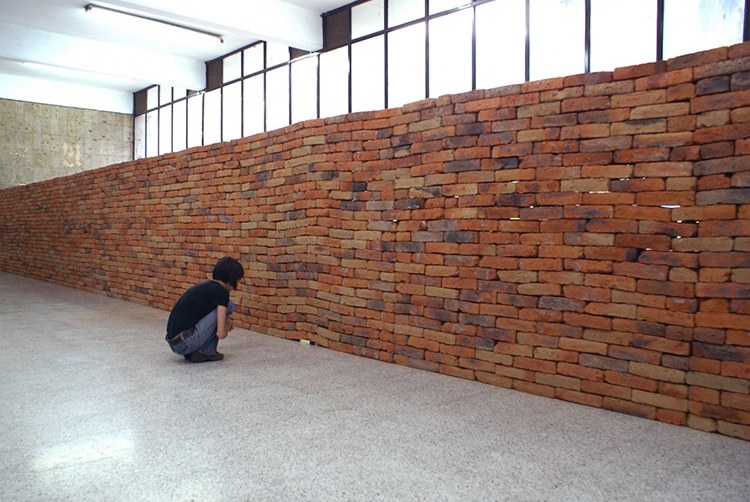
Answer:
[664,0,745,59]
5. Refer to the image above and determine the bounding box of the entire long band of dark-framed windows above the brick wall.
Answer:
[133,0,750,158]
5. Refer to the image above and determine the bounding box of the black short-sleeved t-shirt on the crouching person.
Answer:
[167,281,229,339]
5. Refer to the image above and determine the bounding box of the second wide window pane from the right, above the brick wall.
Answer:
[591,0,656,71]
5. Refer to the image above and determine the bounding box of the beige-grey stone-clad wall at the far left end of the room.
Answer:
[0,99,133,188]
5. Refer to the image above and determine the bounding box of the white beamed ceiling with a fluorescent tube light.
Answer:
[0,0,352,113]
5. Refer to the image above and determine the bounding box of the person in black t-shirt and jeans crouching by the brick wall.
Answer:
[166,256,245,363]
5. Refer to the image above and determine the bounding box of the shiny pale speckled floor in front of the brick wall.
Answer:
[0,272,750,501]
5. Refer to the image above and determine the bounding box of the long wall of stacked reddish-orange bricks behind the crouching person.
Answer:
[0,44,750,439]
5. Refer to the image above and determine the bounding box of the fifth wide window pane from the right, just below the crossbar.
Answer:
[430,9,474,98]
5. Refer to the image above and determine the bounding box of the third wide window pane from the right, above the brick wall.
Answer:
[529,0,586,80]
